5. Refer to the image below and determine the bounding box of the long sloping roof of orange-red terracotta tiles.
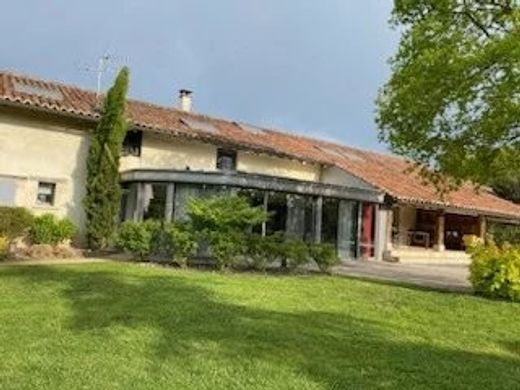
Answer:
[0,71,520,218]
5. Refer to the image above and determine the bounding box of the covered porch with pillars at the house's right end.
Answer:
[385,204,487,262]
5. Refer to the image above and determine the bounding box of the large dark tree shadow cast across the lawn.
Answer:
[4,267,520,389]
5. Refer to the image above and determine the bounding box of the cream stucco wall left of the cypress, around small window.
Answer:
[0,112,88,238]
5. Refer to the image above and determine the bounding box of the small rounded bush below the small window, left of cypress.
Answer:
[30,214,77,245]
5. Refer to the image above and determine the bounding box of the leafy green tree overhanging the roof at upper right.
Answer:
[377,0,520,188]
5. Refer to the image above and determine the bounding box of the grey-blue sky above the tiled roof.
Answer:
[0,0,399,151]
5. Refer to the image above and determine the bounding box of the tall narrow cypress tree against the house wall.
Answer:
[84,67,129,249]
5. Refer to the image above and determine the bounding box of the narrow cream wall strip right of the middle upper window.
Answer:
[237,152,320,181]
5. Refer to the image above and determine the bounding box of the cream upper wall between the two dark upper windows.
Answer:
[121,133,217,171]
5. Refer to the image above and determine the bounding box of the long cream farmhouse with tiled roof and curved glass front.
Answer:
[0,72,520,259]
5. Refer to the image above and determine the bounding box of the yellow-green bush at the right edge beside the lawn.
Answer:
[469,244,520,301]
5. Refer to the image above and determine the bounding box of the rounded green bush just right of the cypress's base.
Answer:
[116,221,160,260]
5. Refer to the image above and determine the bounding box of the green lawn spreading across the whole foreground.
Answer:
[0,263,520,389]
